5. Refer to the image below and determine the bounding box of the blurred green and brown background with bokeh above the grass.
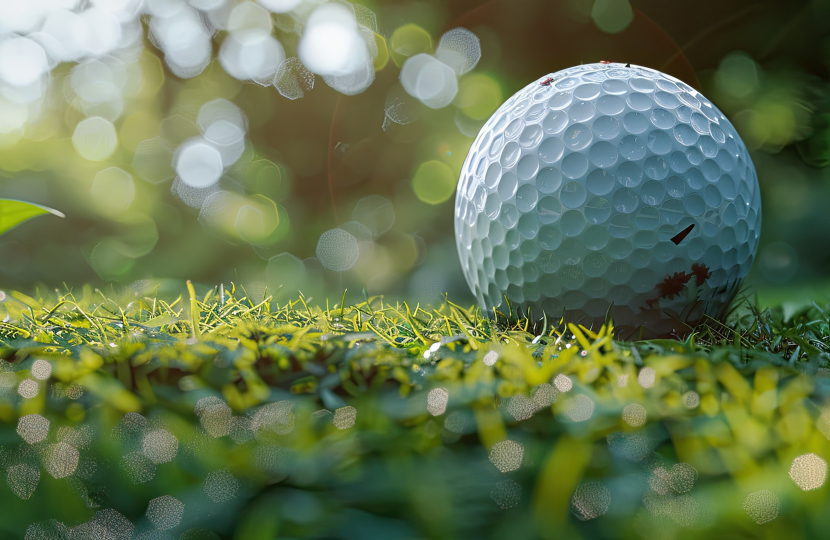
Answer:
[0,0,830,310]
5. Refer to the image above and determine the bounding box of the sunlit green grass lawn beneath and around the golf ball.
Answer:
[0,284,830,539]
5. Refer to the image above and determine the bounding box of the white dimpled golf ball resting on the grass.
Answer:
[455,64,761,338]
